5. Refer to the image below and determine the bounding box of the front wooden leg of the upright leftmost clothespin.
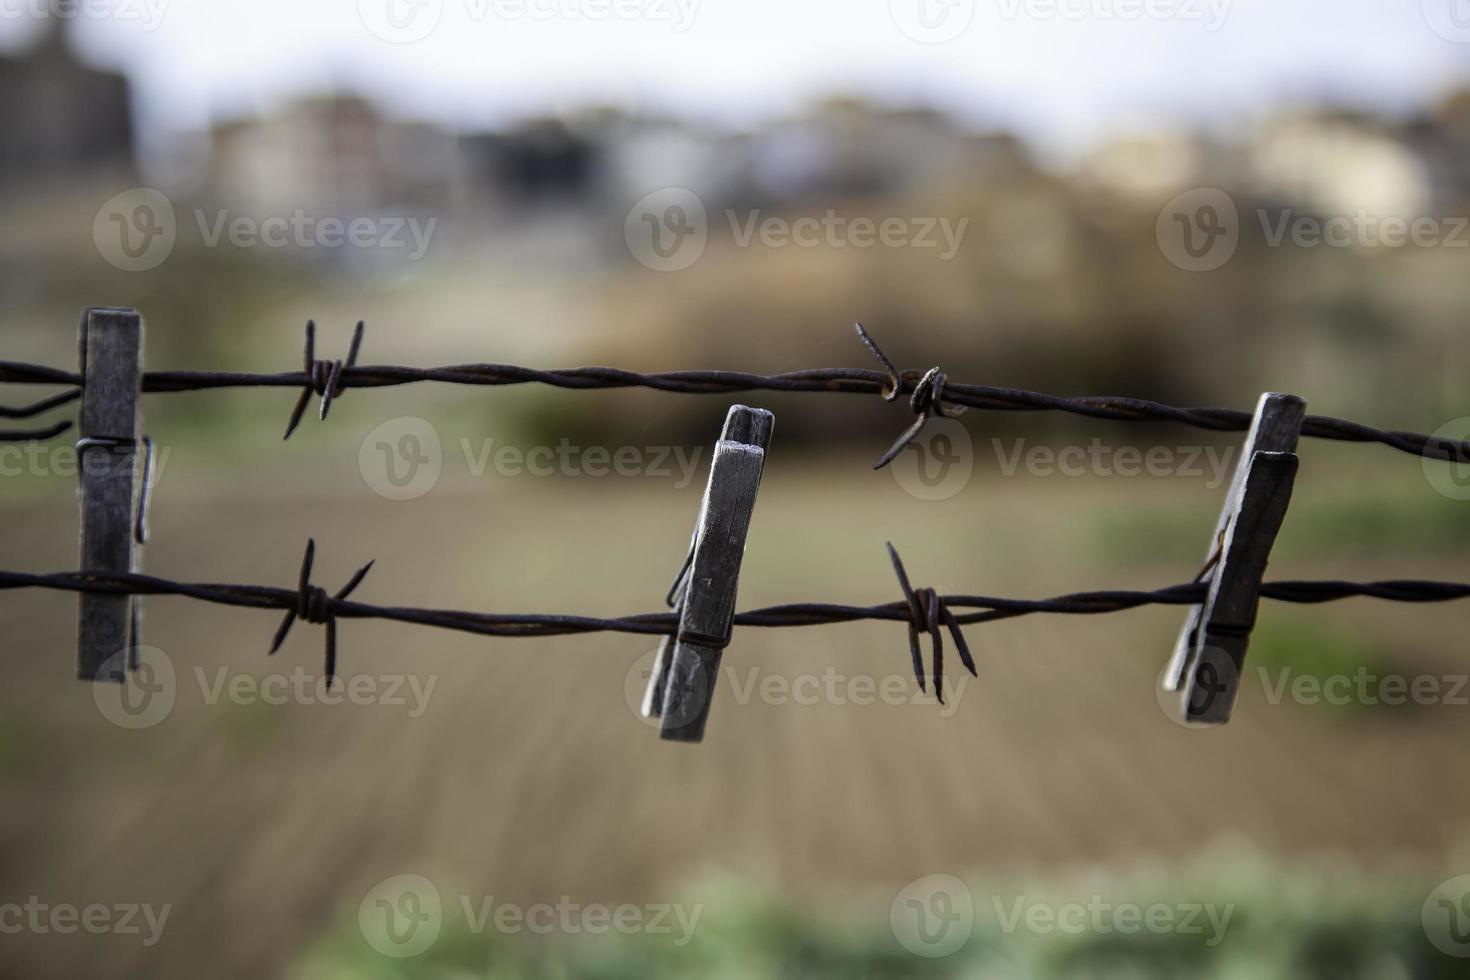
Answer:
[76,307,144,682]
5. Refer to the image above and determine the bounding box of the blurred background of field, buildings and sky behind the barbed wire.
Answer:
[0,0,1470,979]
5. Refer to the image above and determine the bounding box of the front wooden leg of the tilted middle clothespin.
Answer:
[654,406,775,742]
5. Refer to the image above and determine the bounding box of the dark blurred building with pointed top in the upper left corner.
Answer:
[0,18,134,182]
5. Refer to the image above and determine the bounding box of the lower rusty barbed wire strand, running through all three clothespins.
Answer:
[0,541,1470,691]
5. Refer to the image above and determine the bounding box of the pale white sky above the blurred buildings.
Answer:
[0,0,1470,156]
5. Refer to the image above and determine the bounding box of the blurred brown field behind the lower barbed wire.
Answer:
[0,423,1470,977]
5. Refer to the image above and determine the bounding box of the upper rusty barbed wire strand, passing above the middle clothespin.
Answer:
[0,322,1470,469]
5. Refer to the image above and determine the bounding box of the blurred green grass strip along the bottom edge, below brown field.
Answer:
[293,854,1464,980]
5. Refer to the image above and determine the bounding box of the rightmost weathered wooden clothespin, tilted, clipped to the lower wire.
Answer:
[1163,392,1307,724]
